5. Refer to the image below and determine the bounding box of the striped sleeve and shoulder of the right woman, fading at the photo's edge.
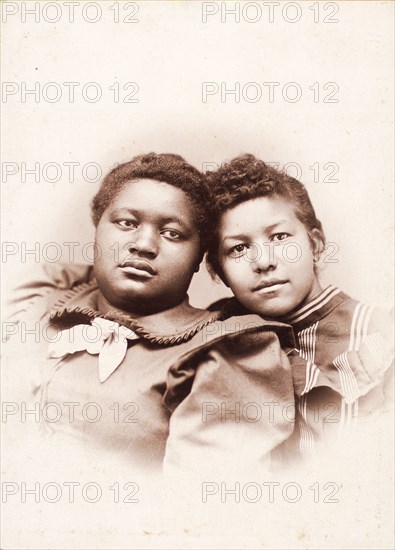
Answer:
[299,292,394,402]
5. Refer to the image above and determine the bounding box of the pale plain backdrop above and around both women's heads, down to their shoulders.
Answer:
[2,2,393,307]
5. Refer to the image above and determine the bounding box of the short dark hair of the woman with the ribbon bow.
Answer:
[91,153,208,252]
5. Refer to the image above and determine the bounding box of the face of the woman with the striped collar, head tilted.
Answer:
[219,197,321,317]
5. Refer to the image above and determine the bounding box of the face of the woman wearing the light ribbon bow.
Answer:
[94,179,201,315]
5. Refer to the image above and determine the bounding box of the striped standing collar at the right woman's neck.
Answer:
[281,285,347,332]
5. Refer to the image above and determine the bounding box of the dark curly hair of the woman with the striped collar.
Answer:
[206,154,325,280]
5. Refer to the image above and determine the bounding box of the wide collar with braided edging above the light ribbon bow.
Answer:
[49,280,218,345]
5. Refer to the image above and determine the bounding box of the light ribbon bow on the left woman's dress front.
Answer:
[48,317,139,382]
